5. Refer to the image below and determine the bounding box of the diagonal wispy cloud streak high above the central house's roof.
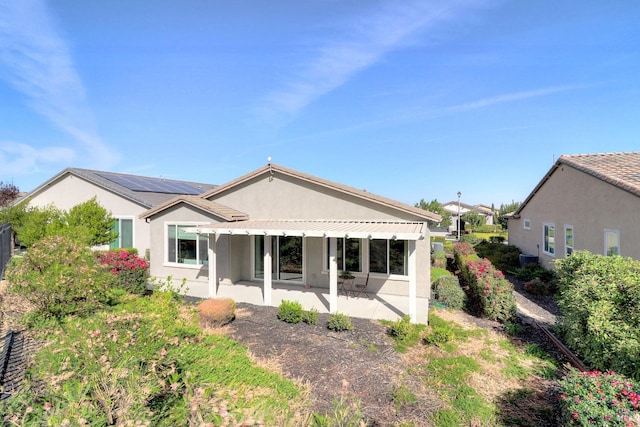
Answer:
[261,0,486,123]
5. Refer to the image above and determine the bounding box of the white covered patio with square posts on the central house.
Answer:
[187,220,428,323]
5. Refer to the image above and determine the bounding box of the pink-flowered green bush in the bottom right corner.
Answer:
[559,370,640,426]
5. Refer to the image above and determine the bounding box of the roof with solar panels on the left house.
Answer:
[20,168,215,209]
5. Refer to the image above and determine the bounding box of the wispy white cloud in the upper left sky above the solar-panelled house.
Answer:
[0,0,116,176]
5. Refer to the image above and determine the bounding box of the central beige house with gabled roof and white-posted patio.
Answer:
[140,164,441,319]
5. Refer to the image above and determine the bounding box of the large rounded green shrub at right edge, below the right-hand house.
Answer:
[555,251,640,380]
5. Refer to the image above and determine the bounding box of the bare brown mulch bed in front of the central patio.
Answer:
[230,303,424,426]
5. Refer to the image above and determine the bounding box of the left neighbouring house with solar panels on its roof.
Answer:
[19,168,215,256]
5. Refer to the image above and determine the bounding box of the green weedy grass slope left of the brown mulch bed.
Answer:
[0,292,306,426]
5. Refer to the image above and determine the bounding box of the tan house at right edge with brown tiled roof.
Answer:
[507,152,640,268]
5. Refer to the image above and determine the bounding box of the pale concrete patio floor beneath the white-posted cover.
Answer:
[211,281,429,325]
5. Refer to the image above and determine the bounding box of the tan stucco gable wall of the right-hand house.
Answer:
[509,165,640,268]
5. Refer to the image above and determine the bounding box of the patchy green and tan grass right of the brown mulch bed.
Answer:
[388,309,558,427]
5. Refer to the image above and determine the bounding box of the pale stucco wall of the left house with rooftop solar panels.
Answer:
[23,175,151,256]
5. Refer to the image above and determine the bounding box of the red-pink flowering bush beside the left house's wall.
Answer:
[98,249,149,295]
